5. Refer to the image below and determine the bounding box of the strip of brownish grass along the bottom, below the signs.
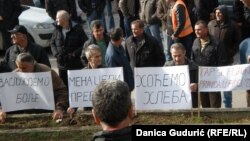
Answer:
[0,109,250,141]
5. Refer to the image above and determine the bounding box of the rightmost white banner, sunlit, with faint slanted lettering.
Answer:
[199,64,250,92]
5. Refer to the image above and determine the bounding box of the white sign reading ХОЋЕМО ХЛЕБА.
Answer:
[135,66,192,110]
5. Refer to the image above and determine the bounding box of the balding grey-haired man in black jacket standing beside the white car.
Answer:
[50,10,88,86]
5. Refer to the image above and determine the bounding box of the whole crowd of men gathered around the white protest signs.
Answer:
[0,0,250,138]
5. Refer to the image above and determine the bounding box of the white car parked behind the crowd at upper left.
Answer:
[0,5,55,50]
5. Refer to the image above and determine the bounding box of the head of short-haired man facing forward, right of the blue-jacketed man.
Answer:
[131,20,144,37]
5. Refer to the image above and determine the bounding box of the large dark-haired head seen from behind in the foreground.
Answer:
[92,80,133,127]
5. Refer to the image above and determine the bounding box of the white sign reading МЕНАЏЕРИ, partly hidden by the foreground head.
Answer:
[68,67,124,107]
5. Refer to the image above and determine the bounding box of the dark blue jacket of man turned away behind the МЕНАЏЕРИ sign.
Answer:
[105,43,134,91]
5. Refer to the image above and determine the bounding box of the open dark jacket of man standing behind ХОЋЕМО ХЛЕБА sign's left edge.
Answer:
[125,32,165,69]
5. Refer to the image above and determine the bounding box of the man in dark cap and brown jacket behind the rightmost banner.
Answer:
[208,5,241,108]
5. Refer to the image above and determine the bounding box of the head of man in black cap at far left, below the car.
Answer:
[9,25,28,45]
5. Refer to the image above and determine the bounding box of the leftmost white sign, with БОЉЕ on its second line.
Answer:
[0,72,55,112]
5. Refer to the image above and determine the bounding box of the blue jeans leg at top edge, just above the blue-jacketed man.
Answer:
[105,0,115,30]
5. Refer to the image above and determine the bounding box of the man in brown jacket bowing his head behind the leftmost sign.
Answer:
[0,53,73,122]
